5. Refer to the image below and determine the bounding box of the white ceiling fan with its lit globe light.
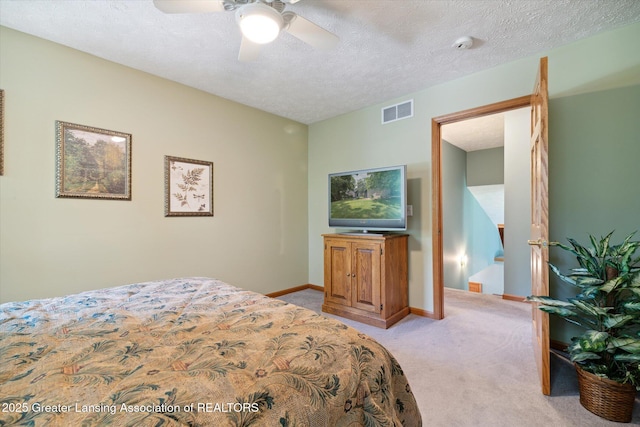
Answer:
[153,0,339,61]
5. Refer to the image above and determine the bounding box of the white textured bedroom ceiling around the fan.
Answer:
[0,0,640,124]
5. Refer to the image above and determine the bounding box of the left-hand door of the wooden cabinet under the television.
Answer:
[324,240,351,306]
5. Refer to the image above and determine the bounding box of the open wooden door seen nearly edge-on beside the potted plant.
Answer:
[529,57,551,395]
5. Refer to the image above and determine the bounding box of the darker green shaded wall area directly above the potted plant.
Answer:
[549,85,640,342]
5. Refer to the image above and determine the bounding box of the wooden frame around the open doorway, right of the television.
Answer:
[431,94,531,320]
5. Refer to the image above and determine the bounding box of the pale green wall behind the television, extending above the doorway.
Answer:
[309,23,640,311]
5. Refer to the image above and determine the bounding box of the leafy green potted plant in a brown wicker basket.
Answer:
[528,232,640,422]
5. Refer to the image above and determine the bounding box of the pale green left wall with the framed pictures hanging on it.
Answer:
[0,28,308,301]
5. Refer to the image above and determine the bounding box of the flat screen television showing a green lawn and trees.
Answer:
[329,165,407,232]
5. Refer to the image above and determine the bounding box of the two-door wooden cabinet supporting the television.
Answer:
[322,233,409,329]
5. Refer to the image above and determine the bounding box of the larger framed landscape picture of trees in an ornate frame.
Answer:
[56,121,131,200]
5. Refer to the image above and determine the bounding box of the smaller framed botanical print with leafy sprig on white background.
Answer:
[164,156,213,216]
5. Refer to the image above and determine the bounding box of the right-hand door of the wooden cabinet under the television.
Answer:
[351,242,382,313]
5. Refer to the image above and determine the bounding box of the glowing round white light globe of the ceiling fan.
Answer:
[236,3,284,44]
